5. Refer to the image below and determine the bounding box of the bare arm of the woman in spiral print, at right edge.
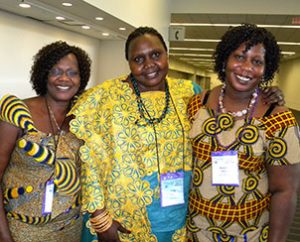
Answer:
[268,164,300,242]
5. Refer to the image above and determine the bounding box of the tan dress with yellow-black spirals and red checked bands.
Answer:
[188,95,300,242]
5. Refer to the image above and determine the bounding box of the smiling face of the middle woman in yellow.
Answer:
[128,34,169,91]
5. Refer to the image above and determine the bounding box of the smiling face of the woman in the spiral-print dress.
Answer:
[225,43,266,91]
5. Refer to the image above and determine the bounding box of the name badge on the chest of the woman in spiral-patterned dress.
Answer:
[211,150,239,186]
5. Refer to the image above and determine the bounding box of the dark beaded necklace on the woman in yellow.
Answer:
[131,76,170,126]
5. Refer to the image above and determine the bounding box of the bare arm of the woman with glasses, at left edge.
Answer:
[0,121,19,242]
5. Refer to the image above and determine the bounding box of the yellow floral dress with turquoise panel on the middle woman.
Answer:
[71,77,198,242]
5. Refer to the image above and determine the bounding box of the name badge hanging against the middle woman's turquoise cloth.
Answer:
[160,171,184,207]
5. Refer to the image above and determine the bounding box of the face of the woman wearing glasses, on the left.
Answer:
[46,54,80,101]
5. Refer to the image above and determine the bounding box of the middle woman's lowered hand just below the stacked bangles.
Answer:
[97,220,131,242]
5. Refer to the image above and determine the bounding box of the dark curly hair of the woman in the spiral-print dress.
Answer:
[214,23,281,86]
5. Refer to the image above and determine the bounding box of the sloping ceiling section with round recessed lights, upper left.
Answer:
[0,0,134,40]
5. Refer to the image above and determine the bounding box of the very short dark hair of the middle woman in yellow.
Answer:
[125,27,168,60]
